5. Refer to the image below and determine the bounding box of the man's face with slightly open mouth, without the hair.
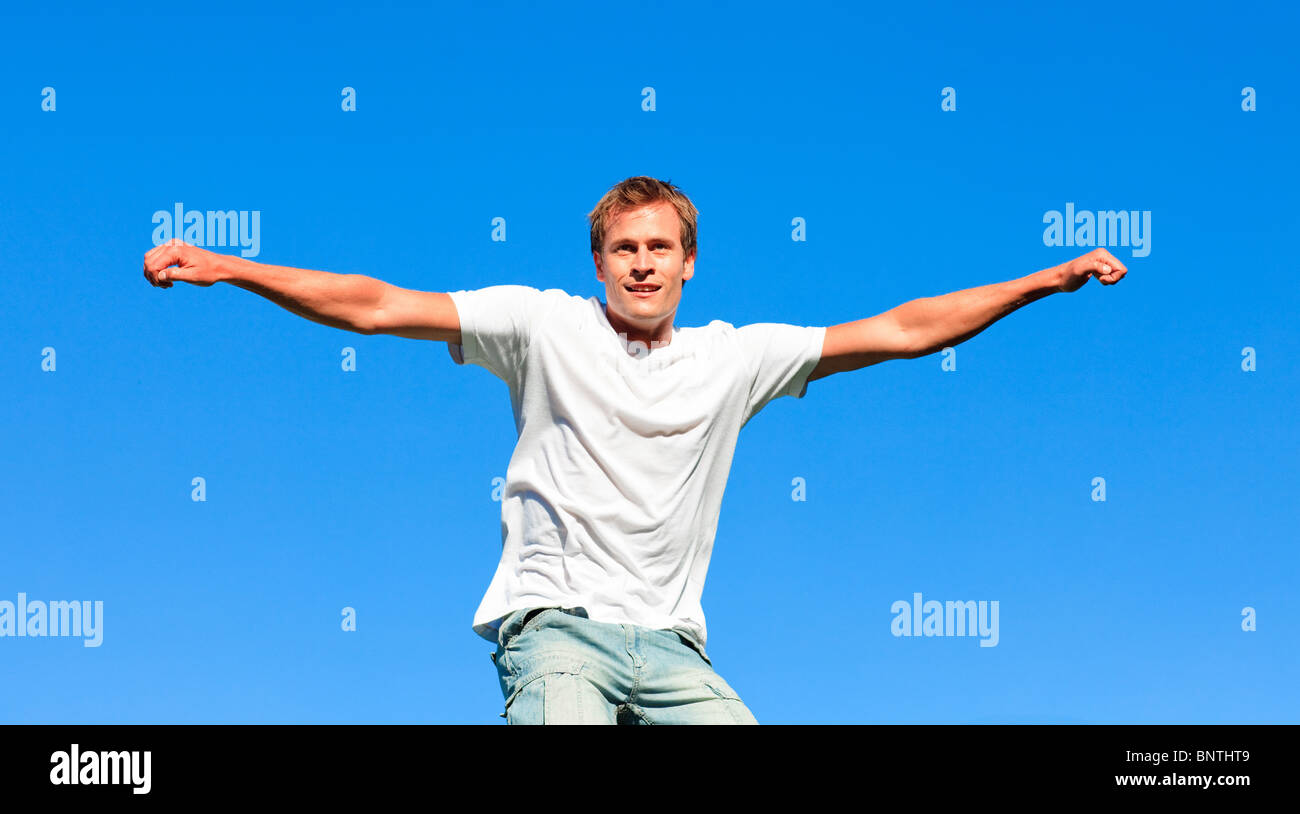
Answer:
[595,202,696,338]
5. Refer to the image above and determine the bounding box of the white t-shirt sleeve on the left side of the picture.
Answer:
[447,285,543,387]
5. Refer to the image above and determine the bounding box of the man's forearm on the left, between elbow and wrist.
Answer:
[217,255,386,333]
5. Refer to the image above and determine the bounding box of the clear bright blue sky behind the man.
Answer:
[0,3,1300,723]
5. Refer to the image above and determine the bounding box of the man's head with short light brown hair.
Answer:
[588,176,699,339]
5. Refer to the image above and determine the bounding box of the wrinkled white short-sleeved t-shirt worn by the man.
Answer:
[447,285,826,648]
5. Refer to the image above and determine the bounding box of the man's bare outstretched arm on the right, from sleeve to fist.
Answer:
[809,248,1128,381]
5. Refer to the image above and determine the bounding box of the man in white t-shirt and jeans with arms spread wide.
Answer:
[137,177,1127,723]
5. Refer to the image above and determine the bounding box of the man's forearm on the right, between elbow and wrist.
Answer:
[893,265,1061,356]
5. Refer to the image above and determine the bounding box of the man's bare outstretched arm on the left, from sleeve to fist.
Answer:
[144,241,460,345]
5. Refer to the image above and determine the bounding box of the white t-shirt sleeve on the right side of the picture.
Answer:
[736,322,826,421]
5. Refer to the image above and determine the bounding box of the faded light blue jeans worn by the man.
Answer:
[493,607,758,724]
